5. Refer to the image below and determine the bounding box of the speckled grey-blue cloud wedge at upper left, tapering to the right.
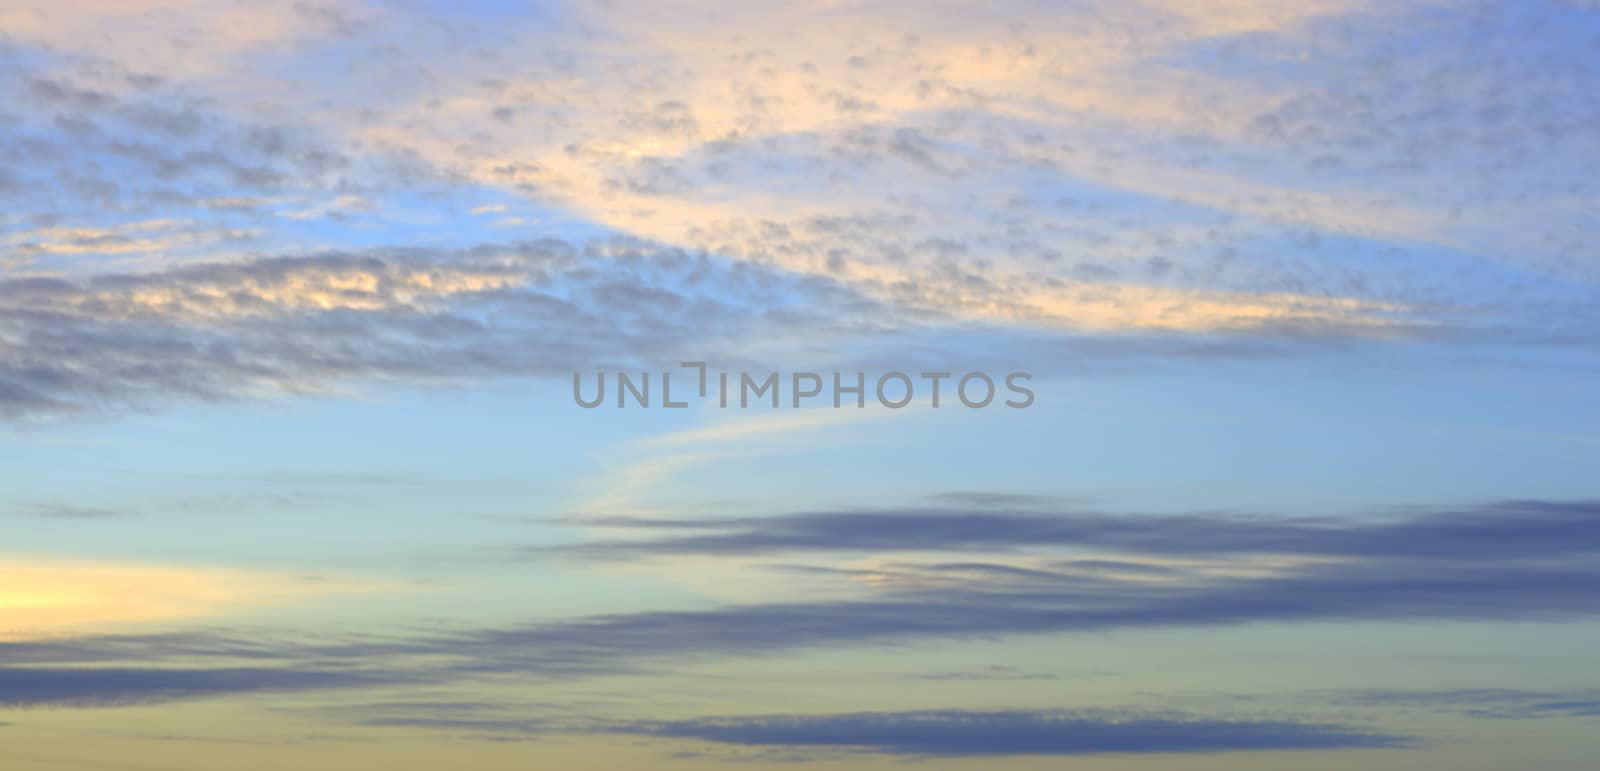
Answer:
[0,55,387,230]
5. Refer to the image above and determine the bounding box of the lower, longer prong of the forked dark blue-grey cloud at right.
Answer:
[396,565,1600,673]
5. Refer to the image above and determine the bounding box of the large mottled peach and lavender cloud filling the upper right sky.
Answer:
[318,2,1594,334]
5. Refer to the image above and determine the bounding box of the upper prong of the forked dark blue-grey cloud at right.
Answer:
[552,494,1600,566]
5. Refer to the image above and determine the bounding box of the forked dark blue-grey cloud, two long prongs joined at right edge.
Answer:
[331,502,1600,670]
